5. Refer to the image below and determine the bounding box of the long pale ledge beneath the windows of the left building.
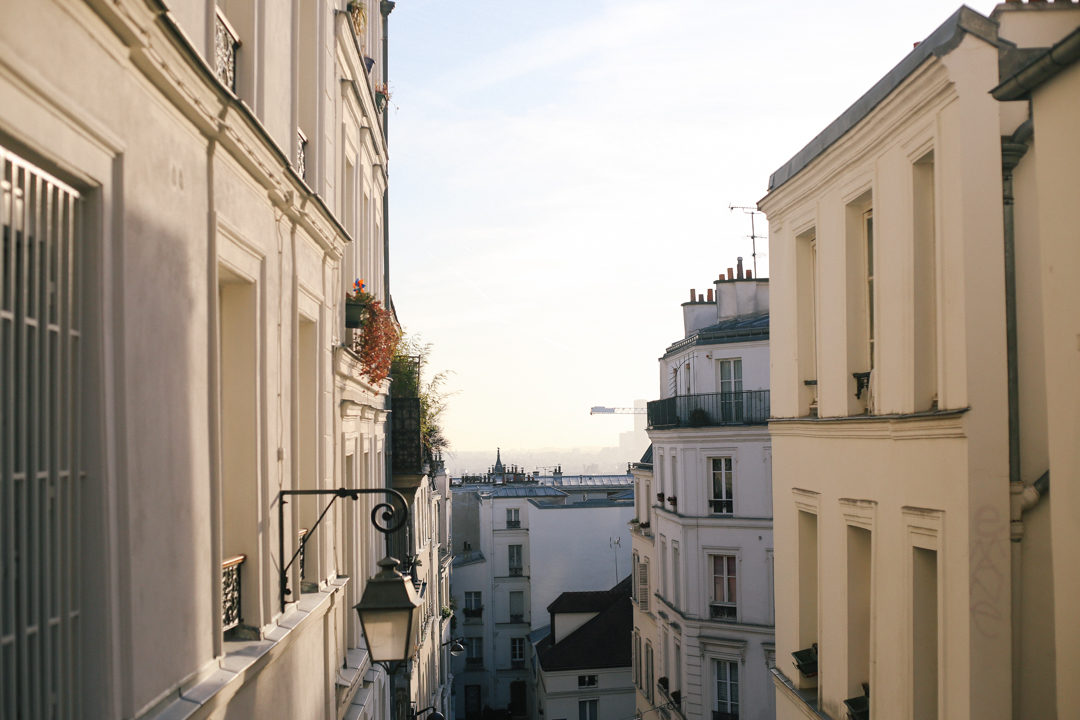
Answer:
[137,578,349,720]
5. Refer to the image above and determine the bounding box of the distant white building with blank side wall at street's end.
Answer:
[451,463,633,719]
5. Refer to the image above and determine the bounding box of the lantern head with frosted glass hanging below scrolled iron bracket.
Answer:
[354,557,421,663]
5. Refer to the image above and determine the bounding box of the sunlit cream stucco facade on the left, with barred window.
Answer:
[0,0,451,718]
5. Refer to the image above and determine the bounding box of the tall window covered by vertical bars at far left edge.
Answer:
[0,143,83,718]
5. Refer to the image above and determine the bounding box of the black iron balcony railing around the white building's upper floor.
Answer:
[647,390,769,430]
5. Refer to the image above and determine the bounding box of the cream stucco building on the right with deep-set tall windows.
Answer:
[759,2,1080,720]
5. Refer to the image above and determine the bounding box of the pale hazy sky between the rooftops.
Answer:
[390,0,994,450]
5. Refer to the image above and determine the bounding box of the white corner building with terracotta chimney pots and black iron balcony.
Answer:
[632,273,774,720]
